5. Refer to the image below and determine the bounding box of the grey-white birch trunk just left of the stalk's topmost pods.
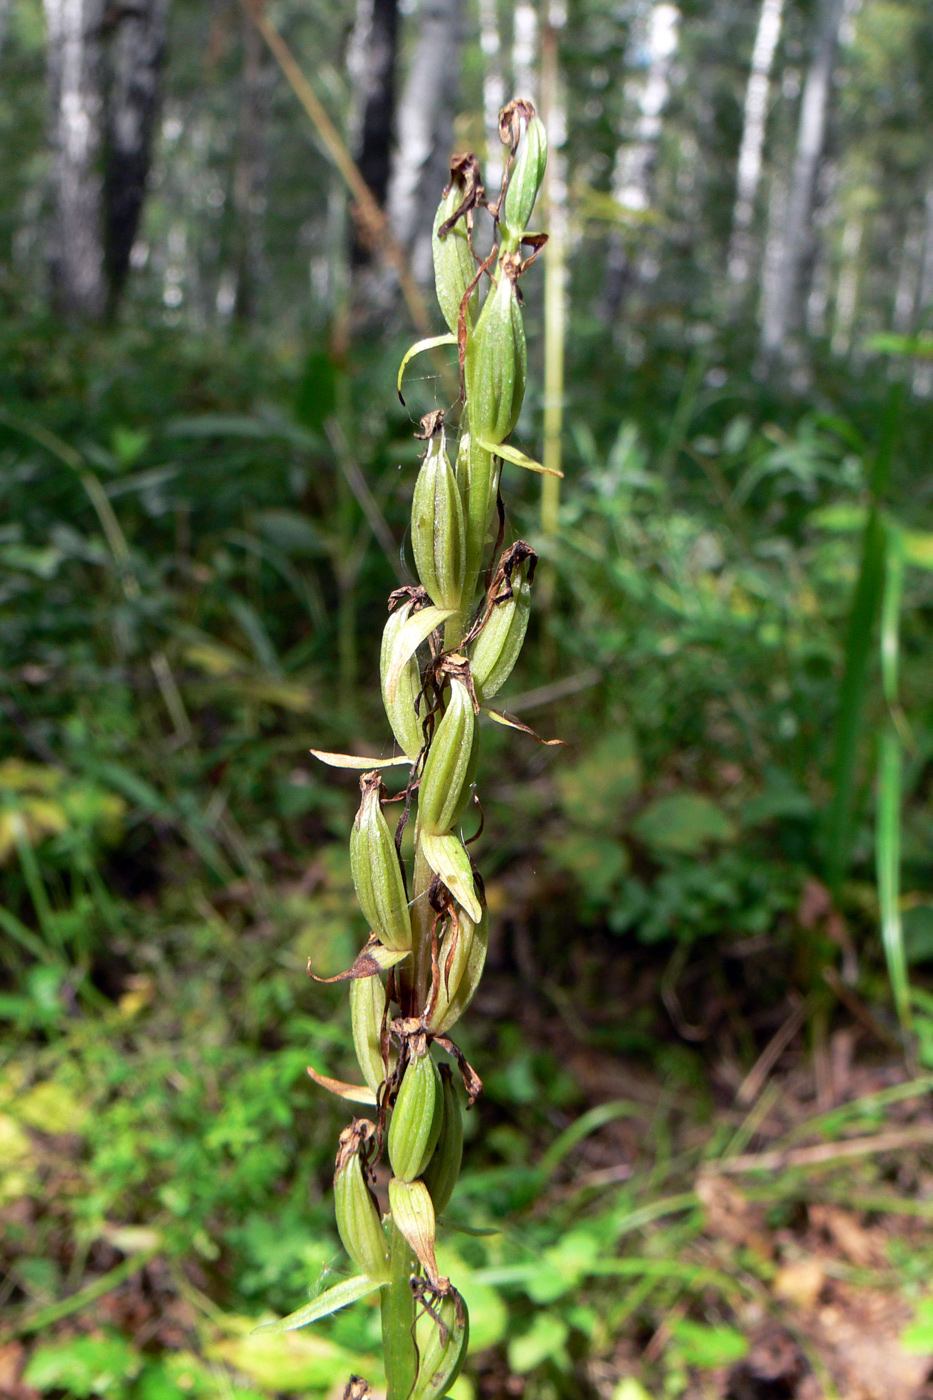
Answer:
[388,0,462,281]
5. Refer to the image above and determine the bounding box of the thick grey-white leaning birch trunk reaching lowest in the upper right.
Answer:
[761,0,846,358]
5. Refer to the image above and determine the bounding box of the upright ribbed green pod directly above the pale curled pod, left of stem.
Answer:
[412,424,467,609]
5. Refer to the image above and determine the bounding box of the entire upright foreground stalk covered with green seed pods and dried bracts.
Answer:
[257,101,546,1400]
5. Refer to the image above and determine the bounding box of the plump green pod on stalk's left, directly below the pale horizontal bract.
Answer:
[350,771,412,952]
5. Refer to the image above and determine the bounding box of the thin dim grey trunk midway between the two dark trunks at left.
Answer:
[233,6,263,322]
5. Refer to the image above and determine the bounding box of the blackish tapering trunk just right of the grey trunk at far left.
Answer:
[104,0,170,309]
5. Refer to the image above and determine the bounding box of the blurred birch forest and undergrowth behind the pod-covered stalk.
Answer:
[0,0,933,1400]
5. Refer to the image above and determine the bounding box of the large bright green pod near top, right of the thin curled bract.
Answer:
[464,256,528,447]
